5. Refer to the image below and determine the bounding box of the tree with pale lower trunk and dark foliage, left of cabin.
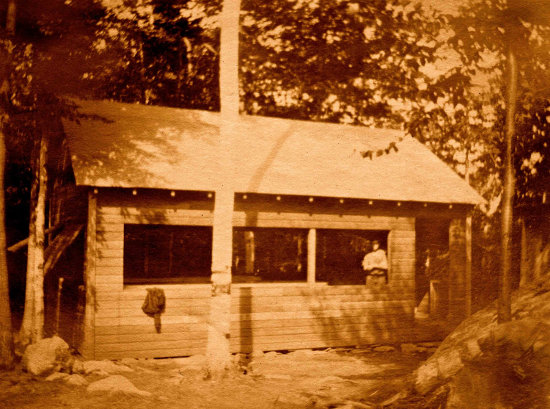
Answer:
[3,0,102,346]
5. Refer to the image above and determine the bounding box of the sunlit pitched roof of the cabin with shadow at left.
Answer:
[64,101,483,204]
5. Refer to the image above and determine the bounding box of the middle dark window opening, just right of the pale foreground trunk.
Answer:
[233,228,308,283]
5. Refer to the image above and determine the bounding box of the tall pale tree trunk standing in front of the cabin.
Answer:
[206,0,240,379]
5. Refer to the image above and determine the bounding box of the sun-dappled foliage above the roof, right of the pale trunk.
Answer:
[241,0,452,126]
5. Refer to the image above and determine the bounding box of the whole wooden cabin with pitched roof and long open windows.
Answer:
[58,101,482,359]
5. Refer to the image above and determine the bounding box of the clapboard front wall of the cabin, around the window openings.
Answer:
[84,190,415,359]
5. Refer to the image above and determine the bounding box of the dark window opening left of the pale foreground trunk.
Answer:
[124,224,212,284]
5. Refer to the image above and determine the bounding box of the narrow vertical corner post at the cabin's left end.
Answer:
[81,190,97,359]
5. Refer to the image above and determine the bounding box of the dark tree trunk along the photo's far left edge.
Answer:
[0,0,15,369]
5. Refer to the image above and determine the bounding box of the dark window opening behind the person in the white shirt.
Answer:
[316,229,389,285]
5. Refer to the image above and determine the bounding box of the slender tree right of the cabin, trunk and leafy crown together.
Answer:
[451,0,550,321]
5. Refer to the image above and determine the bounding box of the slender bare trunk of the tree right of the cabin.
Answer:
[498,46,518,322]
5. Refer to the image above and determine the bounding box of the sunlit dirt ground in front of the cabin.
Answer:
[0,348,427,409]
